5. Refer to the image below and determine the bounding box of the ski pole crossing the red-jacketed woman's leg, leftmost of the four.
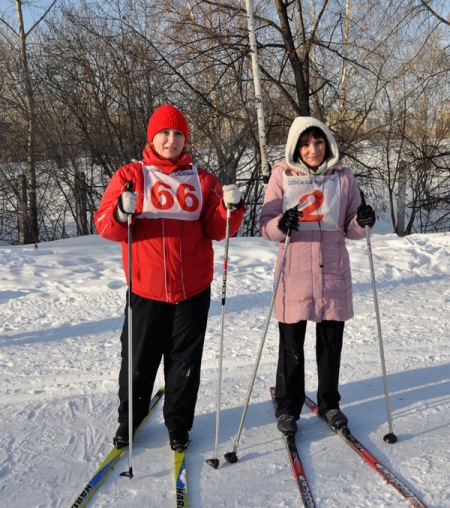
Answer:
[120,180,133,480]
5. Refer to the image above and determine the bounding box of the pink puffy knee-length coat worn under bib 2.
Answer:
[260,119,365,323]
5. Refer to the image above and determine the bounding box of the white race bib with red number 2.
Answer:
[283,173,341,231]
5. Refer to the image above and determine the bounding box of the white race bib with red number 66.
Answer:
[138,164,203,220]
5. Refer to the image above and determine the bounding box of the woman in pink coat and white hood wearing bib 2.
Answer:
[261,117,375,434]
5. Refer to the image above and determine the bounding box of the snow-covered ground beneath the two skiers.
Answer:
[0,230,450,508]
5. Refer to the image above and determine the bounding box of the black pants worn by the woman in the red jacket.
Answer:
[119,288,211,431]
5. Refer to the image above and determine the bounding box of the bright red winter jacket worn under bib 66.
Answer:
[95,148,245,303]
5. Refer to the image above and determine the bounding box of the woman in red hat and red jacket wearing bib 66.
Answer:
[95,104,245,450]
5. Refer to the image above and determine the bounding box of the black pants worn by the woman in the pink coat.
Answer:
[275,321,344,419]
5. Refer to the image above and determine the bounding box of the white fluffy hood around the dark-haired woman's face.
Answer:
[285,116,339,175]
